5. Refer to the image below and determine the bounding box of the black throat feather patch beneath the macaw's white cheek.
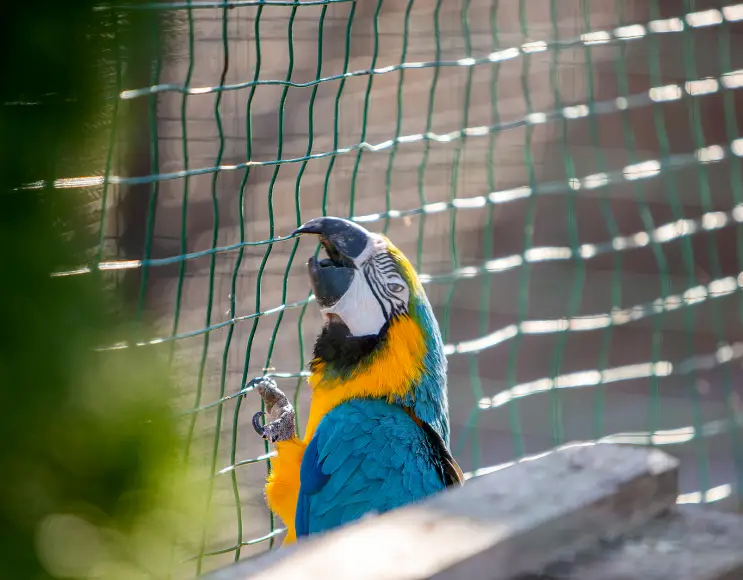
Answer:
[310,321,389,377]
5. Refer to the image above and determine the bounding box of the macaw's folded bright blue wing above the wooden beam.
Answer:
[295,399,444,536]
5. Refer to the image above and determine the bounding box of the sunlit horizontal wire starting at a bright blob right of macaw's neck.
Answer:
[478,342,743,410]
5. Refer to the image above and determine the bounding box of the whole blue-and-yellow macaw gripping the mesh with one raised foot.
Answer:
[253,217,464,544]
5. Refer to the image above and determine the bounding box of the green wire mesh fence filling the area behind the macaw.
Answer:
[80,0,743,573]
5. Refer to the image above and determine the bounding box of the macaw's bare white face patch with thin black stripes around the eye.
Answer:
[320,234,410,336]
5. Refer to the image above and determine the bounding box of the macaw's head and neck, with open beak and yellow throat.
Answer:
[296,217,449,440]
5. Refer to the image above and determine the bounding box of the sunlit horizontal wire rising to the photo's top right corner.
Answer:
[120,0,743,99]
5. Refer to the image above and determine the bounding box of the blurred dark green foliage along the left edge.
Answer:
[0,0,204,580]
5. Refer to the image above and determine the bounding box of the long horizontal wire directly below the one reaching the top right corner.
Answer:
[35,63,743,190]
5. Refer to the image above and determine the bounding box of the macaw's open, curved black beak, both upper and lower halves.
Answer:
[294,217,369,308]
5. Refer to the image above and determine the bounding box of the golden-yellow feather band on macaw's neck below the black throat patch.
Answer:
[304,316,425,441]
